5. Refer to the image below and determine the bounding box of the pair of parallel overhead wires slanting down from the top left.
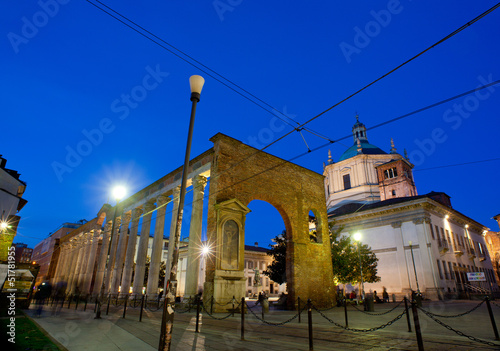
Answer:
[86,0,332,146]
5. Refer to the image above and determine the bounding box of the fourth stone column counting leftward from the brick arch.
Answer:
[132,203,155,295]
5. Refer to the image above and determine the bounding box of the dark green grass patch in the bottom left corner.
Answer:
[0,310,60,351]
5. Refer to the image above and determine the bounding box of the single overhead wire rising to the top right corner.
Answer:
[261,3,500,150]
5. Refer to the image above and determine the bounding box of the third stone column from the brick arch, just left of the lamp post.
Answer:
[146,195,170,298]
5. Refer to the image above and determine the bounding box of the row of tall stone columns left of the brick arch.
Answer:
[50,176,207,296]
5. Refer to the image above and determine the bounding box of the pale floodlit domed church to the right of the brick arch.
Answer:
[323,116,499,299]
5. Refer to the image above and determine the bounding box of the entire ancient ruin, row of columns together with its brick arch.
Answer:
[54,133,335,308]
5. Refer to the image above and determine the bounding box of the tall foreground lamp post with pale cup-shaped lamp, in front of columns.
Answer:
[158,75,205,351]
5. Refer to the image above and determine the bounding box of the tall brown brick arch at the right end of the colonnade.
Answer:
[203,133,335,307]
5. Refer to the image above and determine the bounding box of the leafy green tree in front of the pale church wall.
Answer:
[328,223,380,284]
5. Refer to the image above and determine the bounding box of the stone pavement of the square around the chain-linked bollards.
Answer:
[22,301,500,351]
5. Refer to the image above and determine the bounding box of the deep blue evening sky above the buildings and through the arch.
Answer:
[0,0,500,250]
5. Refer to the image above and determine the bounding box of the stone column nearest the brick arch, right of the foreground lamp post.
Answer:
[184,175,207,297]
